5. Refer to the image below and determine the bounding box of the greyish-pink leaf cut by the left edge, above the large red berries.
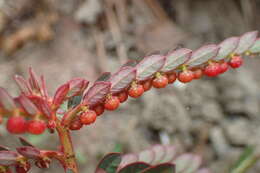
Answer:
[0,87,16,111]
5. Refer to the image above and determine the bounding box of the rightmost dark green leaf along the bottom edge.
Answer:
[140,163,175,173]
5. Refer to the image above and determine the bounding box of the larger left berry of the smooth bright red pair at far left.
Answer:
[6,116,27,134]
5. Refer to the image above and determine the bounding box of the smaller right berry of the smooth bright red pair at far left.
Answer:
[27,120,46,135]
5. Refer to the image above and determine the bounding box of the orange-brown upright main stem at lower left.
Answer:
[56,122,79,173]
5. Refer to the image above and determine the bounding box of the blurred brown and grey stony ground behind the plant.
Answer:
[0,0,260,173]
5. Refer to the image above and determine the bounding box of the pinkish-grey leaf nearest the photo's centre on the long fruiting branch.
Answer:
[109,66,136,94]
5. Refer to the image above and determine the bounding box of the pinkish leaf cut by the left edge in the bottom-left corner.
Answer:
[0,151,19,166]
